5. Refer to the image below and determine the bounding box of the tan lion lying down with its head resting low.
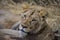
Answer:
[11,9,54,40]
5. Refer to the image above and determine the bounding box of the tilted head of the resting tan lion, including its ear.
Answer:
[21,9,47,33]
